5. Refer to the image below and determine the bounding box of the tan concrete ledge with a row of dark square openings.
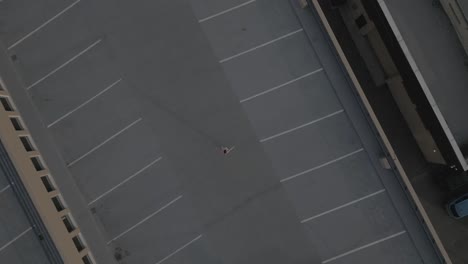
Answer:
[0,42,113,264]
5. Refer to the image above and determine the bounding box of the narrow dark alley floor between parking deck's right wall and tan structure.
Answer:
[318,0,468,264]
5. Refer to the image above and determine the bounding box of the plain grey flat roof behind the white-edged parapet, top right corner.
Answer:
[385,0,468,152]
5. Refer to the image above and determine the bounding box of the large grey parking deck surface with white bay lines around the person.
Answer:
[2,0,438,264]
